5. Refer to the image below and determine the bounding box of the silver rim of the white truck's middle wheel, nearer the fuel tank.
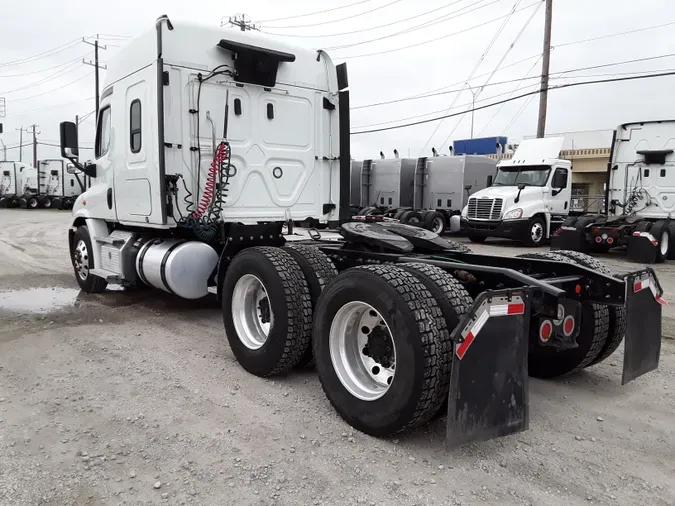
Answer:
[232,274,274,350]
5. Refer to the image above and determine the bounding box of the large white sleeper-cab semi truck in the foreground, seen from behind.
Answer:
[61,16,662,445]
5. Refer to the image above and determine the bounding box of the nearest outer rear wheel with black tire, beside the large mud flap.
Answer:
[313,265,448,437]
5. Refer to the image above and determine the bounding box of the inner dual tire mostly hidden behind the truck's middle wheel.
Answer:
[283,244,337,368]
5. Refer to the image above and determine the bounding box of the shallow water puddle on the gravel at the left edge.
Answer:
[0,287,80,314]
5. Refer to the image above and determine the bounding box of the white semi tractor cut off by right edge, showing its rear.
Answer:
[551,120,675,263]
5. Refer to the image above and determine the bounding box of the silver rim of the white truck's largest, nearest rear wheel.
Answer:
[329,301,396,401]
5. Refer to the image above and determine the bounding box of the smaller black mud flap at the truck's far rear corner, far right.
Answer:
[621,269,666,385]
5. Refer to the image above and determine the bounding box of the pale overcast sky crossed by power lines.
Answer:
[0,0,675,161]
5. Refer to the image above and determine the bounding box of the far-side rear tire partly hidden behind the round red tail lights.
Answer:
[518,251,609,378]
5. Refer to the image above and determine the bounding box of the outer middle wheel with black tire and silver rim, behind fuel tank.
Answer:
[222,246,312,376]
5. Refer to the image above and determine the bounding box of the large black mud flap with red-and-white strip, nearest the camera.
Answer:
[447,290,530,447]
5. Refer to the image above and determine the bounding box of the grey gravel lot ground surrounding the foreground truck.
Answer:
[0,210,675,506]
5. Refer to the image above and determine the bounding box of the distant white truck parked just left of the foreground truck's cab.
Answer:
[38,159,86,209]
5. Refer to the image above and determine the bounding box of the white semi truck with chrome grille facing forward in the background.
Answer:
[460,137,572,246]
